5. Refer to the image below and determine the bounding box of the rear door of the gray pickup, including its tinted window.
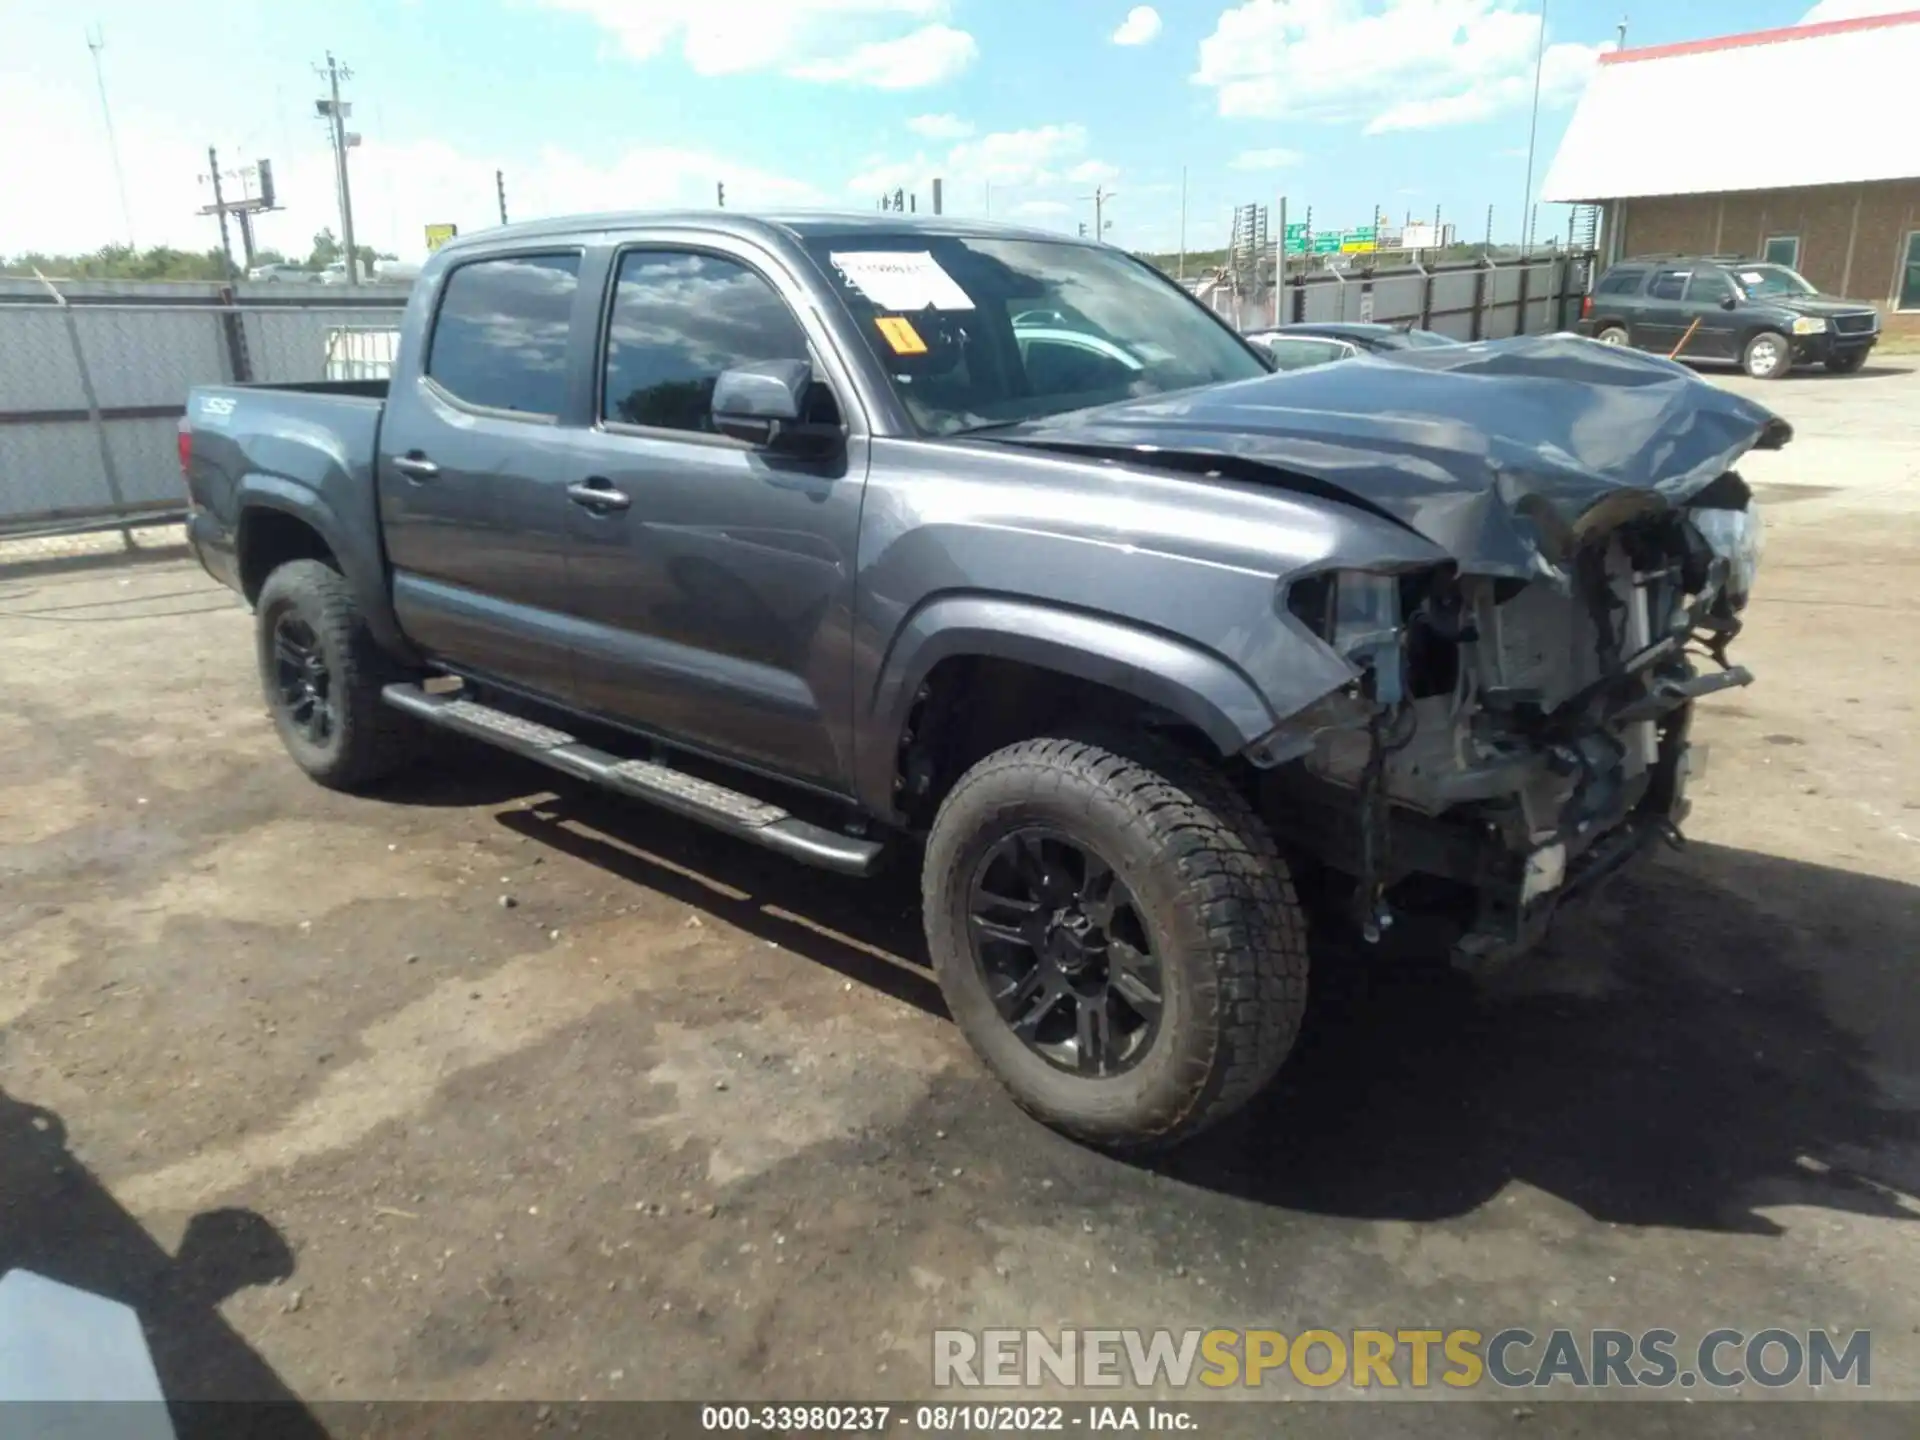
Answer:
[380,244,593,701]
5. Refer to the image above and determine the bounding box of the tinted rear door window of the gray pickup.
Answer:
[426,255,580,419]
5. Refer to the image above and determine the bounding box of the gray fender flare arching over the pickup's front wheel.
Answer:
[858,595,1279,814]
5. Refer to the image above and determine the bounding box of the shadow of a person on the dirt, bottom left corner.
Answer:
[0,1091,324,1440]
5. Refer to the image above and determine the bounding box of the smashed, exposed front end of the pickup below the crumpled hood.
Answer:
[1248,474,1759,966]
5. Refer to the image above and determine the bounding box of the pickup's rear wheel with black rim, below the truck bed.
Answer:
[255,561,419,791]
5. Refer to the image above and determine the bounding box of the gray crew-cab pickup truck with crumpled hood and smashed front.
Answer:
[180,211,1789,1148]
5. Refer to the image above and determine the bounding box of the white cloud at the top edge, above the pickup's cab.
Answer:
[540,0,977,90]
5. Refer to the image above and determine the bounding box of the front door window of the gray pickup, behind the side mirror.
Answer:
[601,250,824,434]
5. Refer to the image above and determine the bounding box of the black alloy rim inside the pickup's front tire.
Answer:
[968,828,1164,1077]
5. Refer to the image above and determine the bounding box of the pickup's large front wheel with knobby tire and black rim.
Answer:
[922,737,1308,1150]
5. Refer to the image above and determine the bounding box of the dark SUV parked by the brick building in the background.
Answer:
[1580,255,1880,380]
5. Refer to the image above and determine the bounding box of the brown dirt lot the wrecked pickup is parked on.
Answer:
[0,367,1920,1434]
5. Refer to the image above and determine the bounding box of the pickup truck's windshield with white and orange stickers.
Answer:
[804,230,1267,436]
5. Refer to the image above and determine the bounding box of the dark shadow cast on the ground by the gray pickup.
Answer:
[464,760,1920,1235]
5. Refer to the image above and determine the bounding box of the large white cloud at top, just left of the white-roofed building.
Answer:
[1194,0,1611,134]
